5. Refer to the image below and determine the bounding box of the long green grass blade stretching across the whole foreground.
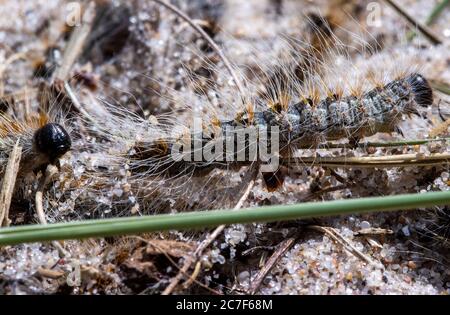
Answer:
[0,191,450,245]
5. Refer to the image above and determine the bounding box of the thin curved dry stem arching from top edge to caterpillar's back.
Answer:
[152,0,245,103]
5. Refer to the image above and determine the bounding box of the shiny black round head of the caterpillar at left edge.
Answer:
[34,123,72,163]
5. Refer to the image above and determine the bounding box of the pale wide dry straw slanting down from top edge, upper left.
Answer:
[52,1,95,82]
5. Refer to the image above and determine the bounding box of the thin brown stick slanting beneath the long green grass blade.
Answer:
[161,166,259,295]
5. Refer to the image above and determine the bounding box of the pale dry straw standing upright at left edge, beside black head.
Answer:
[0,139,22,227]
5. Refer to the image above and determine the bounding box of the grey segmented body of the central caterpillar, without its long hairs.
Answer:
[119,73,433,179]
